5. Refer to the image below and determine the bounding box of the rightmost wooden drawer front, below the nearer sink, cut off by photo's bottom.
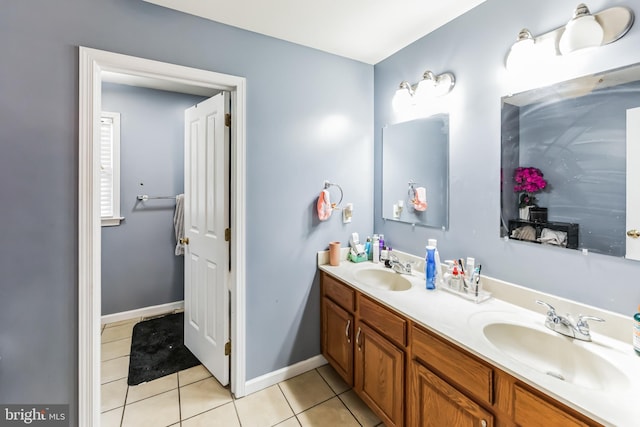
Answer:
[513,384,596,427]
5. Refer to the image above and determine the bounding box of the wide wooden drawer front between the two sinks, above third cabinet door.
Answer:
[411,326,493,405]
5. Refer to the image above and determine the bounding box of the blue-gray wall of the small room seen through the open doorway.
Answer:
[102,83,204,315]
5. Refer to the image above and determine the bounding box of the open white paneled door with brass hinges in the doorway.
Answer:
[184,92,229,385]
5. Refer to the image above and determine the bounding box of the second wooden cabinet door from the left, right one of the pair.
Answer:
[355,322,405,427]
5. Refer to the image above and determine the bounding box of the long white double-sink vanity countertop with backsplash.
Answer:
[318,249,640,427]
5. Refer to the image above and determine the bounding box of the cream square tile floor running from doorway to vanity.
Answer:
[101,319,384,427]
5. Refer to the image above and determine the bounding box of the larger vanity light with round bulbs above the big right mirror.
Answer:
[506,3,634,70]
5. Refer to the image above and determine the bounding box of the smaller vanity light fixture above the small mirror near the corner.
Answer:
[392,70,456,111]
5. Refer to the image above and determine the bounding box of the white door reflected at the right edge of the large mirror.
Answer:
[626,108,640,260]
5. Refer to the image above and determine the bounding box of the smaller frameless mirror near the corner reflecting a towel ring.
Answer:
[382,114,449,229]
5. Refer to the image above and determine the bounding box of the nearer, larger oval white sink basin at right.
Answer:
[483,323,629,391]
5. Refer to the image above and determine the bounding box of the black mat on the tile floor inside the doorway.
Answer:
[127,313,200,385]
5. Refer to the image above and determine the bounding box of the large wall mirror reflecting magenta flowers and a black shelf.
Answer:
[500,65,640,259]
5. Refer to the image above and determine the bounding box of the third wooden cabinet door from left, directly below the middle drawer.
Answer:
[409,361,494,427]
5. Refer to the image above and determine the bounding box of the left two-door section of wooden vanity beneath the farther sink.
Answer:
[321,272,407,427]
